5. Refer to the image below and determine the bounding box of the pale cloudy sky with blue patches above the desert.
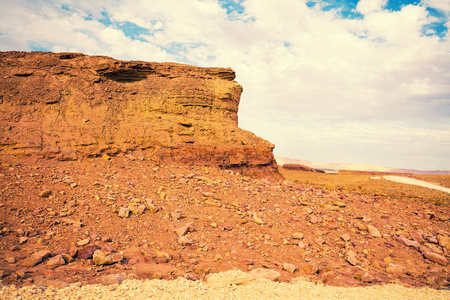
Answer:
[0,0,450,170]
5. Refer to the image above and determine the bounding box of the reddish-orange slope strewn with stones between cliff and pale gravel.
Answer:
[0,156,450,288]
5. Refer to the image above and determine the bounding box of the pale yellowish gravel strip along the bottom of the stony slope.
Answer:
[0,270,450,300]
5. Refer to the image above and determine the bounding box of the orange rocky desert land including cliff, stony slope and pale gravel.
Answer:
[0,52,450,299]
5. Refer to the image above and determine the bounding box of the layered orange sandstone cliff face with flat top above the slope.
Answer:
[0,52,276,176]
